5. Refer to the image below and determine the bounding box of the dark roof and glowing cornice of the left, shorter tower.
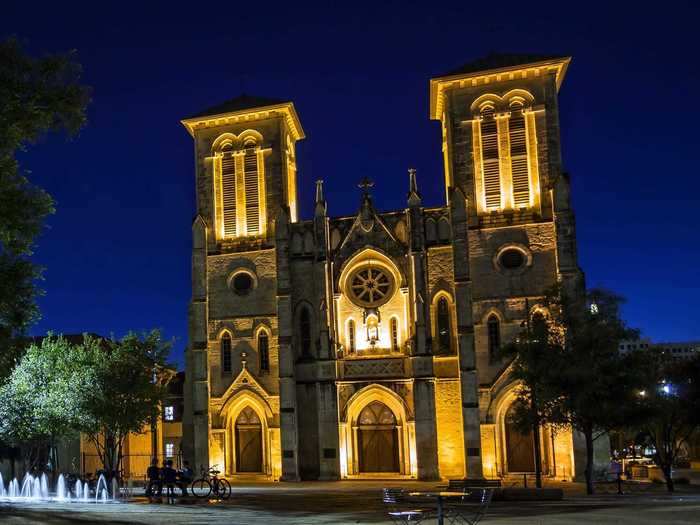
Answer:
[180,94,304,140]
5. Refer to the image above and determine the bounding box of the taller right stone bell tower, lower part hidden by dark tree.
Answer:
[430,55,583,477]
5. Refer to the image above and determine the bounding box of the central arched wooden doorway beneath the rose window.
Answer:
[357,401,399,473]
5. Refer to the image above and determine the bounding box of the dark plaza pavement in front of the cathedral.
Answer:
[0,481,700,525]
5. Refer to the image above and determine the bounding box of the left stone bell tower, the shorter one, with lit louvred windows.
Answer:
[182,96,304,478]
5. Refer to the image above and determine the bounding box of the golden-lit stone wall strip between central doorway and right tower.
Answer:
[435,380,464,479]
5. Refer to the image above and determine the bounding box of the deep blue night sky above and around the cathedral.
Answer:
[0,1,700,363]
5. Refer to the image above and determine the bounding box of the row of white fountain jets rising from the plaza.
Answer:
[0,473,119,503]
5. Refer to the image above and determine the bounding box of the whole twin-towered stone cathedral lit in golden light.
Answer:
[182,55,596,480]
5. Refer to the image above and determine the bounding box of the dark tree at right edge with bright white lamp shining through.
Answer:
[638,350,700,492]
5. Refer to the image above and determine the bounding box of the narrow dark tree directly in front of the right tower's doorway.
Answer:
[500,302,562,488]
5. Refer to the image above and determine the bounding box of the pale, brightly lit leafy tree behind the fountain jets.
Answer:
[0,336,86,472]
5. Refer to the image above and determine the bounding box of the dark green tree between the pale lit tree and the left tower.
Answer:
[80,330,170,474]
